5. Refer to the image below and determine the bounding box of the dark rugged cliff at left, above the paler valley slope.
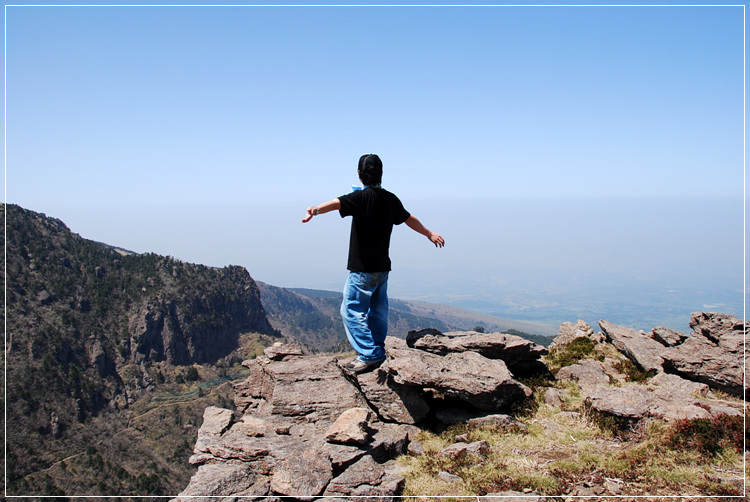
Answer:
[2,205,278,494]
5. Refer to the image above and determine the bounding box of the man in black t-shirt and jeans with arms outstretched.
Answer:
[302,154,445,373]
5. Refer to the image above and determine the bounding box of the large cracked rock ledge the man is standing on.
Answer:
[179,331,544,501]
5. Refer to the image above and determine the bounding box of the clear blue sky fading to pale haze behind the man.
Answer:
[5,6,744,334]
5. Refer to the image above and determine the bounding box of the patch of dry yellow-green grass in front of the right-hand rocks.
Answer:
[399,382,744,502]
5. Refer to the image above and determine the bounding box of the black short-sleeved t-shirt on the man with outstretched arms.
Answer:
[339,187,410,272]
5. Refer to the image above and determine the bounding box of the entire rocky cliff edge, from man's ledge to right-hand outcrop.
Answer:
[178,313,747,501]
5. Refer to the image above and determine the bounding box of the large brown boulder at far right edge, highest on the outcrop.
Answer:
[662,312,748,396]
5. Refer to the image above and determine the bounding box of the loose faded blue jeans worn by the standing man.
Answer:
[341,272,388,362]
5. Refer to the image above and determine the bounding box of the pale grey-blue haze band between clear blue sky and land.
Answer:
[22,194,744,331]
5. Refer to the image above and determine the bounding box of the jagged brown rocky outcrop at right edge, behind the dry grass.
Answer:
[549,313,746,423]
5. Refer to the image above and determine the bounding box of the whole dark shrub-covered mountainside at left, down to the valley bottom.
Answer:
[2,205,278,495]
